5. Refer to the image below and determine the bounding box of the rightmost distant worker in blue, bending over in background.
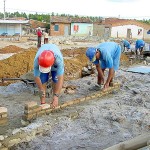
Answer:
[135,39,145,55]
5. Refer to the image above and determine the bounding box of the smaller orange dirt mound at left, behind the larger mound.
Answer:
[0,45,25,54]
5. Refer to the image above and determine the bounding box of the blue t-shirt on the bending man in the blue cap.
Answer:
[94,42,121,70]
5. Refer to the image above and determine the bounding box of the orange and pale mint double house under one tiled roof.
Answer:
[50,16,93,36]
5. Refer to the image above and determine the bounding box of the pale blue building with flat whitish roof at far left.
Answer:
[0,20,29,36]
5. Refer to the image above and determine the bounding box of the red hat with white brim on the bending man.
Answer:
[38,50,54,73]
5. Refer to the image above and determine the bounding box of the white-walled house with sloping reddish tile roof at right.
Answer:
[105,18,150,40]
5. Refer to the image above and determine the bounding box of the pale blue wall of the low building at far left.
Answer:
[0,24,22,35]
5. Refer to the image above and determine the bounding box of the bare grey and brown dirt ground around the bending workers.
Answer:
[0,38,150,150]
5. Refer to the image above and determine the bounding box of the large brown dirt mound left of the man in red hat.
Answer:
[0,48,37,78]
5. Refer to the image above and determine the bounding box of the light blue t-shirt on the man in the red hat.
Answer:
[34,44,64,77]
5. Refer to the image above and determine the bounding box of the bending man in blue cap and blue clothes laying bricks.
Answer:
[86,42,121,90]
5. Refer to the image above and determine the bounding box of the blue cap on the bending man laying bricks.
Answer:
[86,47,96,62]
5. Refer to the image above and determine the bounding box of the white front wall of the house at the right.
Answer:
[111,25,143,39]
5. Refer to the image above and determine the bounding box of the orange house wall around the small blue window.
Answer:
[50,23,70,36]
